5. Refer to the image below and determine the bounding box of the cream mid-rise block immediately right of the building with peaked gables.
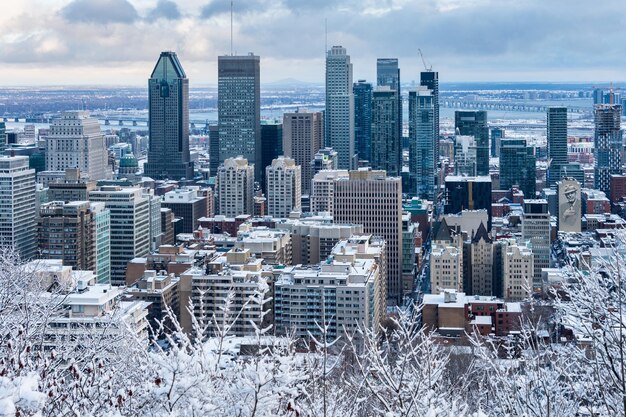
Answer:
[502,242,535,300]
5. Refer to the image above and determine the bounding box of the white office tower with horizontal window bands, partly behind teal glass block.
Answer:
[89,186,150,285]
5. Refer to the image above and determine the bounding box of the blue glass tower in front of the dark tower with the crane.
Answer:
[408,87,438,201]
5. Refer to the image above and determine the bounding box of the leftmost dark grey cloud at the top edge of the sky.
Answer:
[61,0,139,24]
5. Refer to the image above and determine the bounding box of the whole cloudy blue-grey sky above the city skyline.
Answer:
[0,0,626,85]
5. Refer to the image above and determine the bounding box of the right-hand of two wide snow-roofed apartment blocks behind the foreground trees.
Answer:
[274,236,386,339]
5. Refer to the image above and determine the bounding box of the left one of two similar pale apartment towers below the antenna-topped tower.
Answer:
[217,157,254,217]
